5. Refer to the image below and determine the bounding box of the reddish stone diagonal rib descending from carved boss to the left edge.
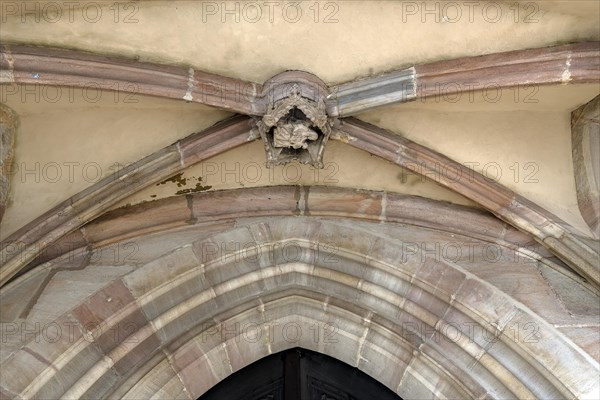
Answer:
[0,117,248,284]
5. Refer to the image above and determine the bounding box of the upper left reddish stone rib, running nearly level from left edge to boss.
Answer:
[2,45,260,113]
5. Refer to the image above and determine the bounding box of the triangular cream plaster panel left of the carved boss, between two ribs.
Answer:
[0,86,230,238]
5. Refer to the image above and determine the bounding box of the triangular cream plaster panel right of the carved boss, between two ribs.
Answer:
[359,85,598,234]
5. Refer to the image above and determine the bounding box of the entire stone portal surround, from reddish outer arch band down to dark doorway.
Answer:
[1,188,599,399]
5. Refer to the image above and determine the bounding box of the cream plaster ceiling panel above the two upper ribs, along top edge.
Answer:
[1,1,600,83]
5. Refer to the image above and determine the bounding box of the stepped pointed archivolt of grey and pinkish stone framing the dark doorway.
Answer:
[0,217,600,399]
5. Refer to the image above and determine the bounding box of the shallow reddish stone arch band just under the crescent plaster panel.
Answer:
[21,186,553,269]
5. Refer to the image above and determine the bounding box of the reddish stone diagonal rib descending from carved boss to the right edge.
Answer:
[340,118,600,289]
